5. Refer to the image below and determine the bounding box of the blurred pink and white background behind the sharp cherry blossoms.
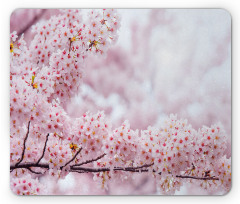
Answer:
[10,9,231,195]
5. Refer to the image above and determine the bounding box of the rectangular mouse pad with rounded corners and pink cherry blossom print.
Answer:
[10,9,231,195]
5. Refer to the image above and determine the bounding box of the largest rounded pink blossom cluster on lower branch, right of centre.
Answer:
[142,115,196,175]
